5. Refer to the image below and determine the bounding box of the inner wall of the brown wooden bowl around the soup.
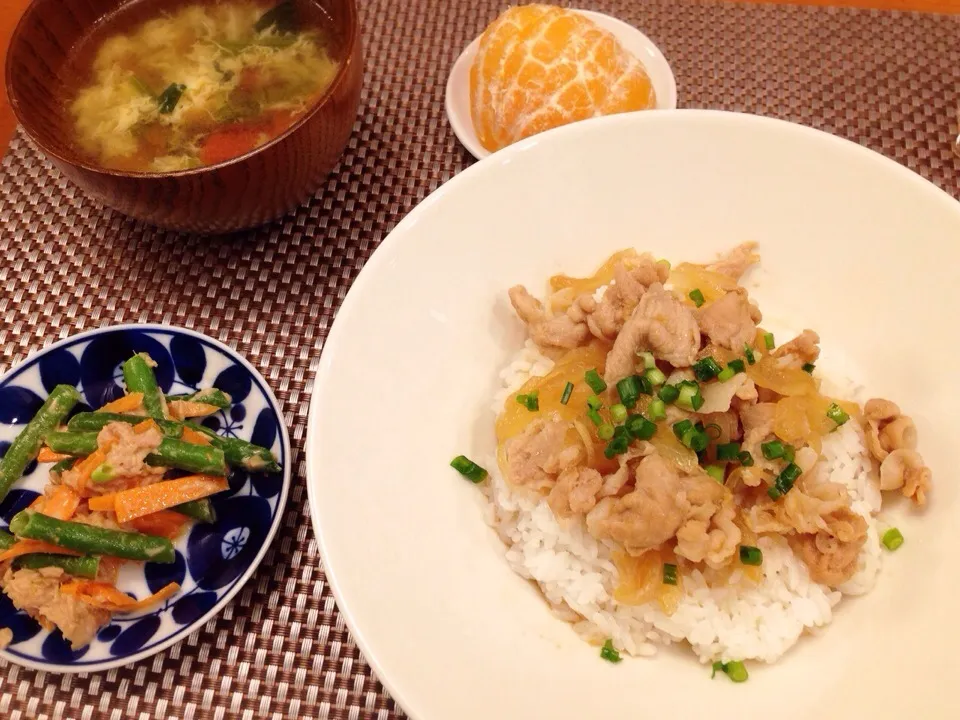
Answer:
[6,0,359,175]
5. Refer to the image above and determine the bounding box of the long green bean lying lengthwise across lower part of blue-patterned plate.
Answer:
[10,510,176,563]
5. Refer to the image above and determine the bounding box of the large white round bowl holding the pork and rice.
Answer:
[307,111,960,720]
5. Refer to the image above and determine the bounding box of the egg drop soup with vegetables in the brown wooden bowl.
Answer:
[67,0,338,172]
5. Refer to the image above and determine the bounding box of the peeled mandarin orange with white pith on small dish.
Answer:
[470,5,656,151]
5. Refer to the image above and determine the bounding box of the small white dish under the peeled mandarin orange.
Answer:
[444,10,677,160]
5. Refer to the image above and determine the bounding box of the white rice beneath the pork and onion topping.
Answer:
[485,341,881,663]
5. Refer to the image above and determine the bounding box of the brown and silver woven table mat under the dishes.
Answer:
[0,0,960,720]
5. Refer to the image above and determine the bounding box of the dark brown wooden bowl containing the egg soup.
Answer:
[6,0,363,232]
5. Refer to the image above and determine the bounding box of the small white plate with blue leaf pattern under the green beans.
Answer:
[0,325,290,672]
